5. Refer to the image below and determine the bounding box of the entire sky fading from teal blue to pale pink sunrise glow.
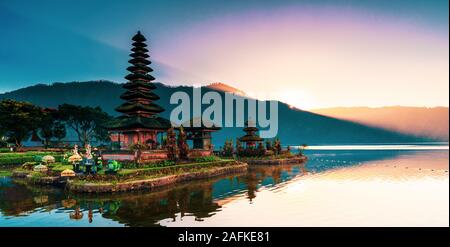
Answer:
[0,0,449,109]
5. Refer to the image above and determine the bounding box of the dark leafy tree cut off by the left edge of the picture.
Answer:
[0,99,42,149]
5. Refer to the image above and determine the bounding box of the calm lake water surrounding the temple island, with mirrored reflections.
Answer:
[0,144,449,226]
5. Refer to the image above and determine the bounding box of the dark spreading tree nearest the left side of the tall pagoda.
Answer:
[58,104,112,146]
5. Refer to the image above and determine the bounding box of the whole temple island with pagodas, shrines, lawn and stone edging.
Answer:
[6,32,307,193]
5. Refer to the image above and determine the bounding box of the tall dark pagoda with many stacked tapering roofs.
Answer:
[108,32,171,149]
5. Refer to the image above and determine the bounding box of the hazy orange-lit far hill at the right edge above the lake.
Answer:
[311,106,449,141]
